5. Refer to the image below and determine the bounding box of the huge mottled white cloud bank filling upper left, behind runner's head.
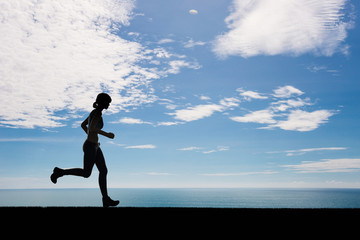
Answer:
[0,0,199,128]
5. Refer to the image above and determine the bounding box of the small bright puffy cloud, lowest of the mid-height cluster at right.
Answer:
[269,110,335,132]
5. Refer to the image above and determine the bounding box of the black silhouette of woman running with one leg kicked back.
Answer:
[50,93,120,207]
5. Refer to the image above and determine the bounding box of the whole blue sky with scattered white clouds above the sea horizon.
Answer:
[0,0,360,188]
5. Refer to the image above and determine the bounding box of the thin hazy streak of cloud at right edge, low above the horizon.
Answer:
[281,158,360,173]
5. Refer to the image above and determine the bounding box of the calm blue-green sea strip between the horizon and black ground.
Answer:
[0,188,360,208]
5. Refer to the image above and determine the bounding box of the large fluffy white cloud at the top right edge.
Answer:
[213,0,353,57]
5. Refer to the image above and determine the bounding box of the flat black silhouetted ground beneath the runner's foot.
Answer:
[0,207,360,236]
